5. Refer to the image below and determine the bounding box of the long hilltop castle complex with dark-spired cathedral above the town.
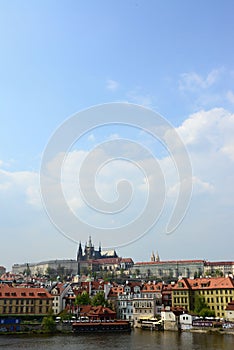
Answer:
[12,237,234,280]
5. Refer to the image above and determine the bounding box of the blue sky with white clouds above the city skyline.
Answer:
[0,0,234,270]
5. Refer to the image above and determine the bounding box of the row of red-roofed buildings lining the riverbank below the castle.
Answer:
[0,277,234,326]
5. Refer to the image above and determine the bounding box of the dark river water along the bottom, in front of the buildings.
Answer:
[0,330,234,350]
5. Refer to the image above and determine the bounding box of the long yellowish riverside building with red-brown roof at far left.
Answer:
[0,285,53,316]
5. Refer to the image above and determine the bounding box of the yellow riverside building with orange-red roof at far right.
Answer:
[172,277,234,317]
